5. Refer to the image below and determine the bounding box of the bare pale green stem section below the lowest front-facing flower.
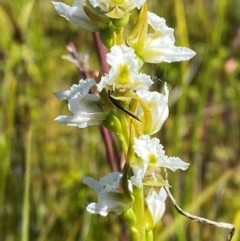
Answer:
[133,186,146,241]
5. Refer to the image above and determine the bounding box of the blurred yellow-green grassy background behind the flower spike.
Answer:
[0,0,240,241]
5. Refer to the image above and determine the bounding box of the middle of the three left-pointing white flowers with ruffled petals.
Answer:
[55,78,106,128]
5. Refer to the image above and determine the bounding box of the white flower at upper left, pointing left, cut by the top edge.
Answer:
[52,0,98,32]
